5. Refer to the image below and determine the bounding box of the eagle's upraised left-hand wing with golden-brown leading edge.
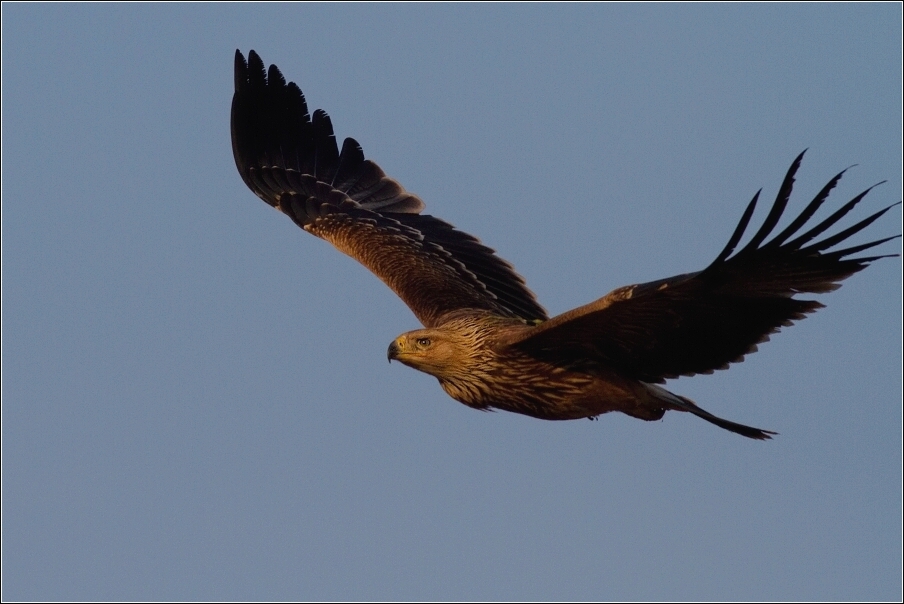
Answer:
[232,50,547,327]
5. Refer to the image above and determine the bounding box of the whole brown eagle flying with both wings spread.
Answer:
[231,50,899,440]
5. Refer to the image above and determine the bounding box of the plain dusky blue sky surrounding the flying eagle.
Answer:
[2,4,902,601]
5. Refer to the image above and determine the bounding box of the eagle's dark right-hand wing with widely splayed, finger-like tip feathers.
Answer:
[510,153,900,383]
